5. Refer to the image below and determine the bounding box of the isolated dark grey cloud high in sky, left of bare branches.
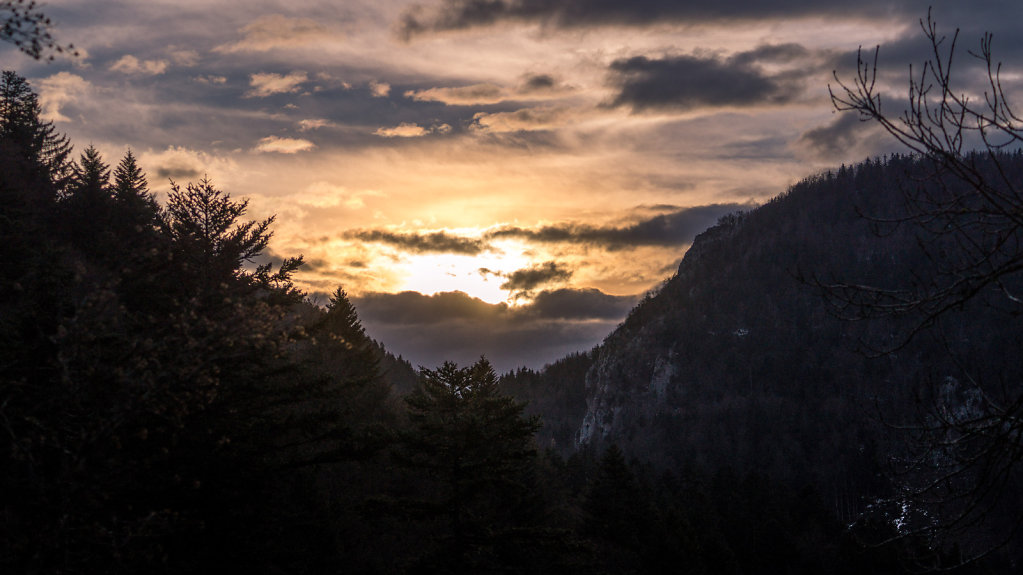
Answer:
[610,44,819,112]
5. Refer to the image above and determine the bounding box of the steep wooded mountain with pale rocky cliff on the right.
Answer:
[506,147,1023,552]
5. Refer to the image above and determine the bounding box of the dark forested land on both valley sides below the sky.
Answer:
[0,13,1023,574]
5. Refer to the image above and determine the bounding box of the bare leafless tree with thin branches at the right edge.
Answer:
[821,13,1023,561]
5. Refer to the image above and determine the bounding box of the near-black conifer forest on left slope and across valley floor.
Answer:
[0,72,1006,574]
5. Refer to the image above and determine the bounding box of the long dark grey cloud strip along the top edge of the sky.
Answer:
[399,0,916,39]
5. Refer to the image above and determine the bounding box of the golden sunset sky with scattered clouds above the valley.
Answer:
[0,0,1023,371]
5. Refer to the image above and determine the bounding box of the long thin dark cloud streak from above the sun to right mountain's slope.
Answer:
[490,204,749,250]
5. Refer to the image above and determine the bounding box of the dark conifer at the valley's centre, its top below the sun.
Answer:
[399,358,539,573]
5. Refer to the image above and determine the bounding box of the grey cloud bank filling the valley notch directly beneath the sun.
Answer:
[352,290,637,371]
